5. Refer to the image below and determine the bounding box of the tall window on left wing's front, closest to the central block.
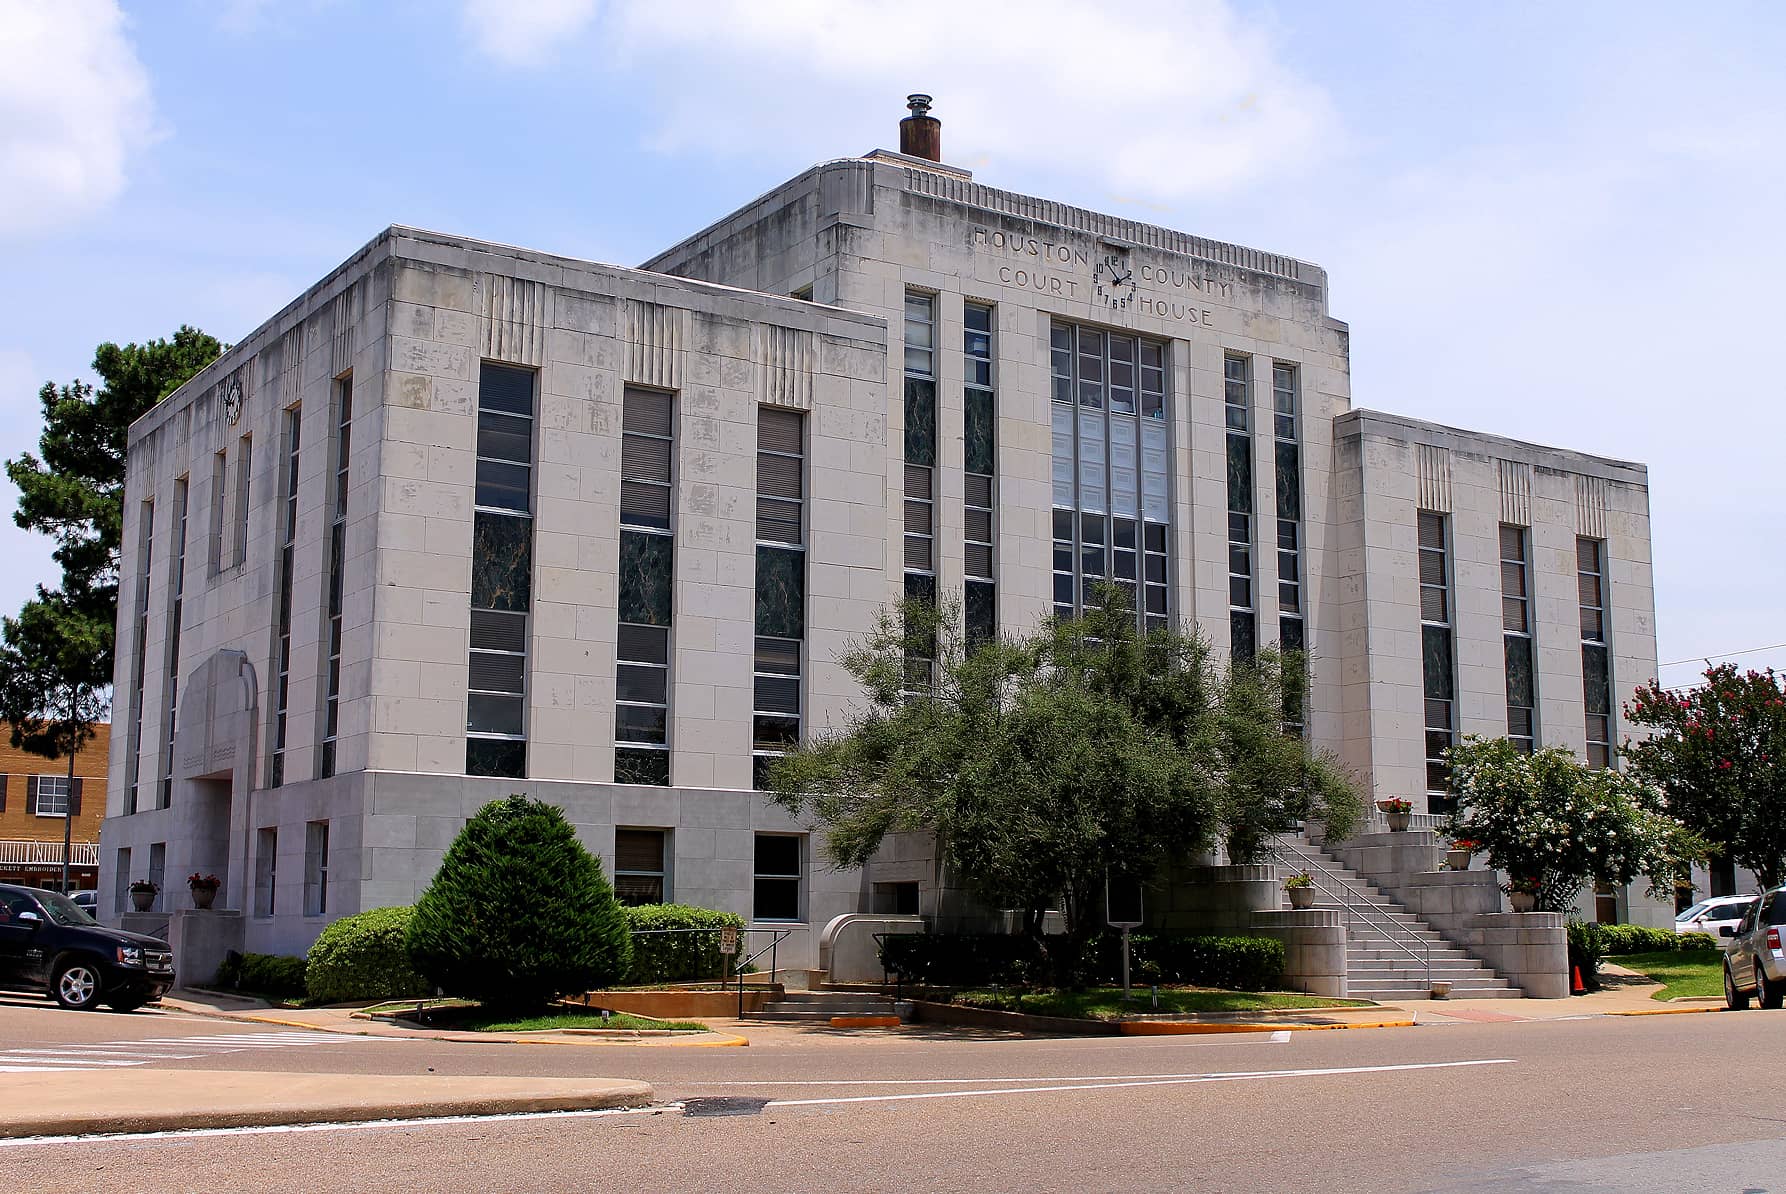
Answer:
[750,407,805,789]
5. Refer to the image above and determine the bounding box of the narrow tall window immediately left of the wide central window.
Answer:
[961,303,998,648]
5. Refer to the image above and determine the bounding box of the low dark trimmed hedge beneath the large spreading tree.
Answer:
[880,933,1284,991]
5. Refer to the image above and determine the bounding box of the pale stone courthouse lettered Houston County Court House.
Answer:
[102,97,1656,966]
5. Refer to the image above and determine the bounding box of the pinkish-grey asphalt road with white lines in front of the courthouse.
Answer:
[0,1001,1786,1194]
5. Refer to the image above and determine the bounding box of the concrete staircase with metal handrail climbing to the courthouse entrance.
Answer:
[1275,833,1522,1001]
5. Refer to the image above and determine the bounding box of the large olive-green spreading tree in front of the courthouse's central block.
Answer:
[770,587,1361,980]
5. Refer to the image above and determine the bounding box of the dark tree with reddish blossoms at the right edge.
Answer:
[1623,664,1786,889]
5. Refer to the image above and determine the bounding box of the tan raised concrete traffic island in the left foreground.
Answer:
[0,1069,654,1137]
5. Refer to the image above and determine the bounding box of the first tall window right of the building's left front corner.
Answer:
[464,361,534,780]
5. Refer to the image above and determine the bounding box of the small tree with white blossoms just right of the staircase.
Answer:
[1445,734,1700,912]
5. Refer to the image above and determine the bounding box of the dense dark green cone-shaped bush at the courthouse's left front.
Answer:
[404,796,632,1014]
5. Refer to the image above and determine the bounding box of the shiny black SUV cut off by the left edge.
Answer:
[0,883,173,1012]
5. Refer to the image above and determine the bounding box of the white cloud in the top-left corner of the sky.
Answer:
[0,0,155,236]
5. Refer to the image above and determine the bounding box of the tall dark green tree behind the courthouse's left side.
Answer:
[0,327,223,887]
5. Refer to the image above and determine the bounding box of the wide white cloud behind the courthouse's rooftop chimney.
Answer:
[464,0,1338,200]
